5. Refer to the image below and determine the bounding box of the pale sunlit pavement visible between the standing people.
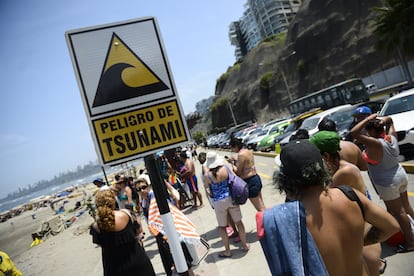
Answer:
[150,149,414,276]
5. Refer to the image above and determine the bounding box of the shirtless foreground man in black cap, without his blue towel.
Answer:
[266,140,399,276]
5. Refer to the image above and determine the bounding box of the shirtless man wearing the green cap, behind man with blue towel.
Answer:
[310,131,386,275]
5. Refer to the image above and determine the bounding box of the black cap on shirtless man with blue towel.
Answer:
[280,140,323,177]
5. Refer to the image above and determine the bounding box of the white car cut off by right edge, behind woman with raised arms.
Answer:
[379,88,414,156]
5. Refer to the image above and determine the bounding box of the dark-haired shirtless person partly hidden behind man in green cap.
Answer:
[318,118,368,171]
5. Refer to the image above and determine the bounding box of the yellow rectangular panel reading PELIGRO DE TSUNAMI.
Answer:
[92,100,188,164]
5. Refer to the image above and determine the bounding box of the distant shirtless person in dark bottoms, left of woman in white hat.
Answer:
[180,151,203,208]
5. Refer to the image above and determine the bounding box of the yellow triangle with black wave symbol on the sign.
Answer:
[92,32,169,107]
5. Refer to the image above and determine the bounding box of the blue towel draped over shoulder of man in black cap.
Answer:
[256,201,328,276]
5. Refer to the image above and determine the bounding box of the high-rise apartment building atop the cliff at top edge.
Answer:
[229,0,302,60]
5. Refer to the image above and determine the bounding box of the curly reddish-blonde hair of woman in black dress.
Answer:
[95,190,116,231]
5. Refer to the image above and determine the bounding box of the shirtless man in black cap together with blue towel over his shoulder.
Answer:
[256,140,399,275]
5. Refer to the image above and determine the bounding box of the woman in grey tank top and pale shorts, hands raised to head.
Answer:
[351,114,414,253]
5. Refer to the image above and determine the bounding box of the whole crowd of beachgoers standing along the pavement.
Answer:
[86,104,414,275]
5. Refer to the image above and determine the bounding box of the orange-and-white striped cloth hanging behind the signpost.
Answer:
[148,198,200,244]
